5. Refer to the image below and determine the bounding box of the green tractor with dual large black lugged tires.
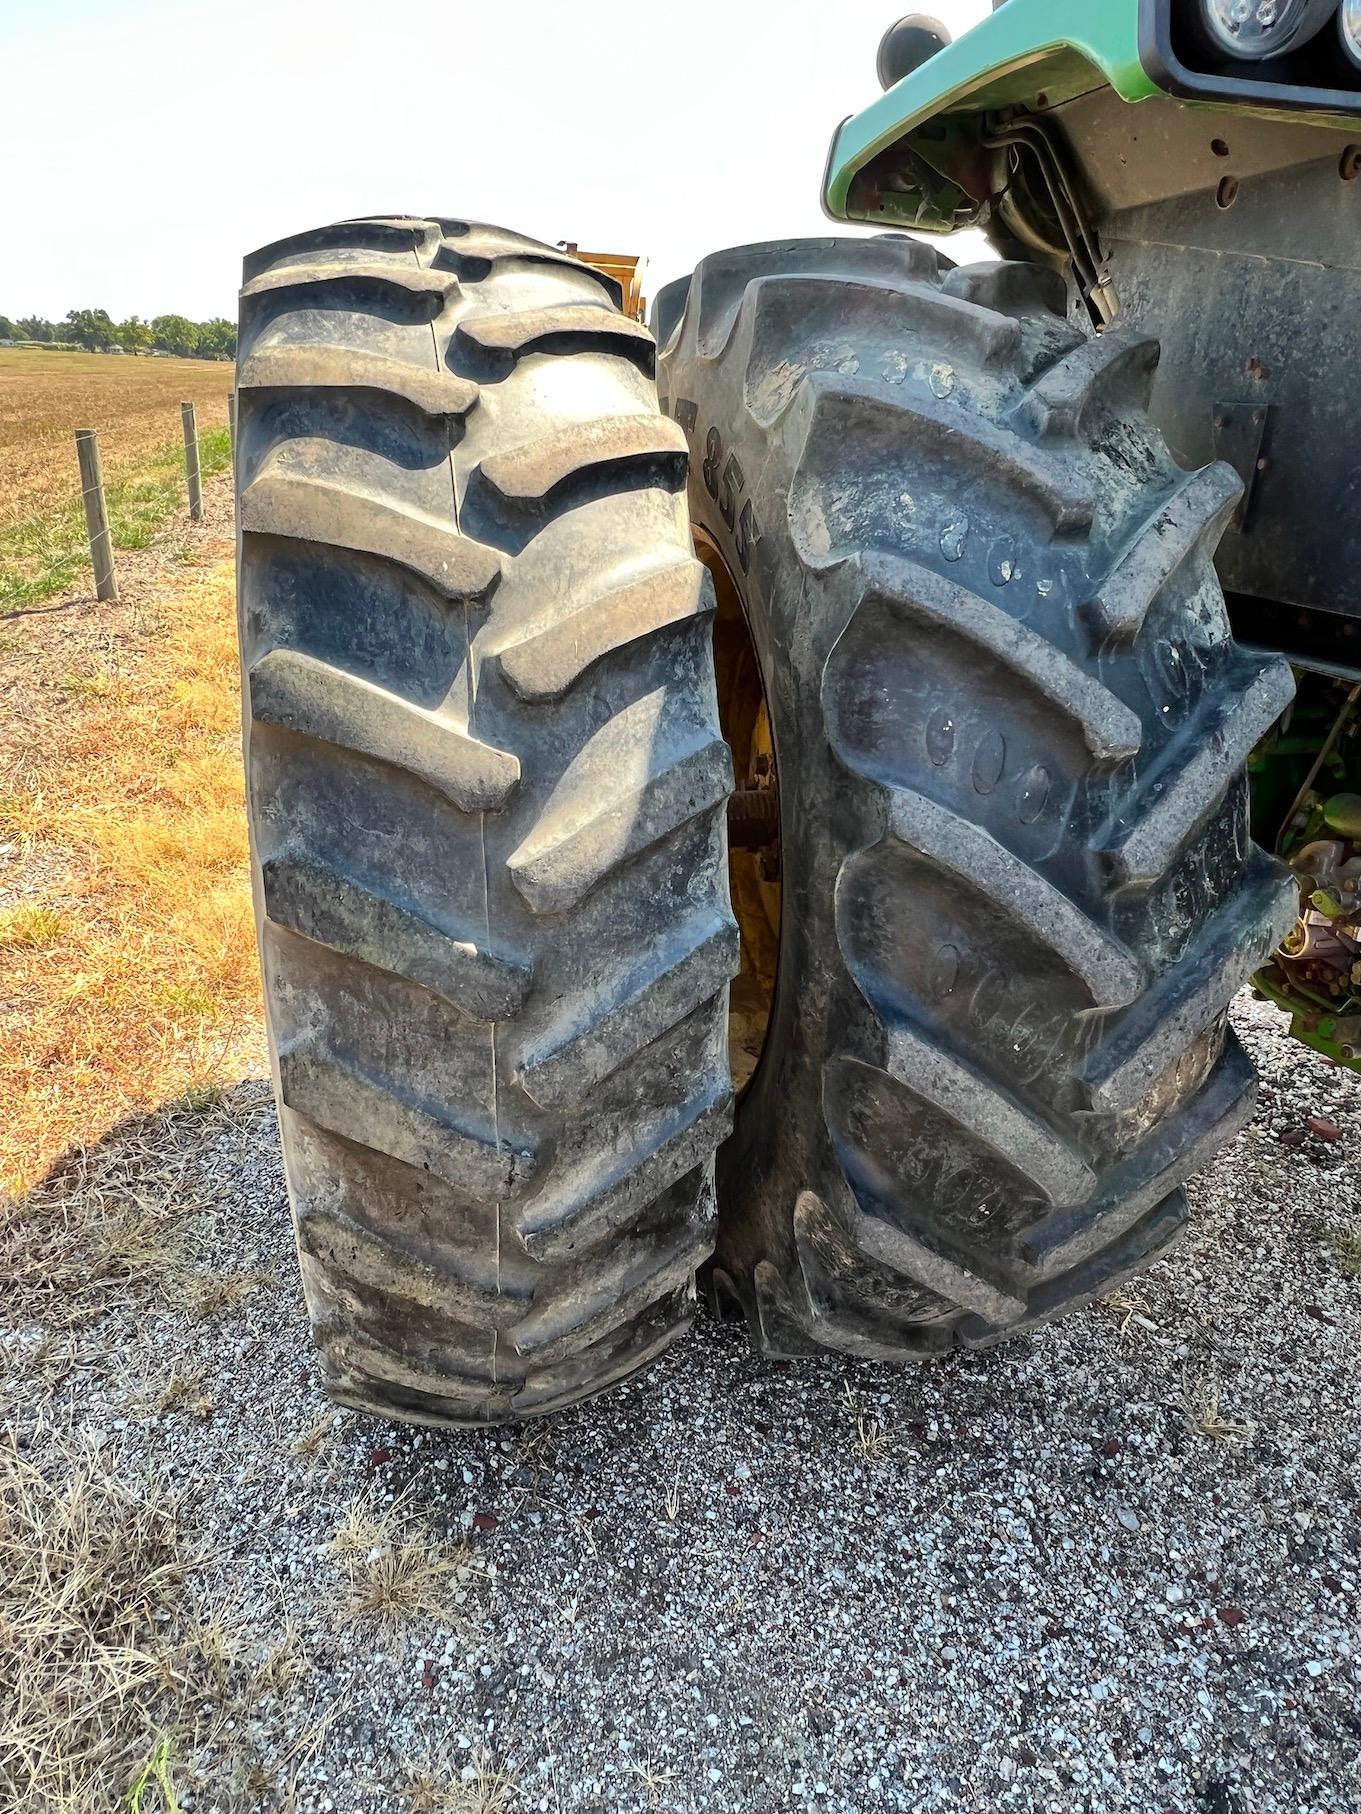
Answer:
[238,0,1361,1424]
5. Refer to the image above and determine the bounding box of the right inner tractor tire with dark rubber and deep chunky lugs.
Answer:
[653,236,1296,1359]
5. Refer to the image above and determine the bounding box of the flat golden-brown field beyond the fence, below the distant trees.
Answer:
[0,346,232,532]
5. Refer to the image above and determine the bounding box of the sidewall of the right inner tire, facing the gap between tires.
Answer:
[662,360,884,1291]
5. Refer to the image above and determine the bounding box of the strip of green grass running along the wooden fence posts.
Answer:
[0,428,232,611]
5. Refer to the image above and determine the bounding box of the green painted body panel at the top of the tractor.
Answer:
[822,0,1356,232]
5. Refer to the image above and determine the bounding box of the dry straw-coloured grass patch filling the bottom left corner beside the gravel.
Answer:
[0,1439,332,1814]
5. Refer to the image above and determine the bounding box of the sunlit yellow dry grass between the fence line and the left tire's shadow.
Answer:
[0,533,259,1192]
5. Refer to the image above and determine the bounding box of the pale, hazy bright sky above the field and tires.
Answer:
[0,0,987,317]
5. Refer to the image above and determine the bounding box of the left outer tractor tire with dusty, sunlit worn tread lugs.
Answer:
[236,218,737,1424]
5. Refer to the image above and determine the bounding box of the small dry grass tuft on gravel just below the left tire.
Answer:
[330,1500,483,1631]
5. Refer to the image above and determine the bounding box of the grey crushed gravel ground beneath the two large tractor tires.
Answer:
[0,1001,1361,1814]
